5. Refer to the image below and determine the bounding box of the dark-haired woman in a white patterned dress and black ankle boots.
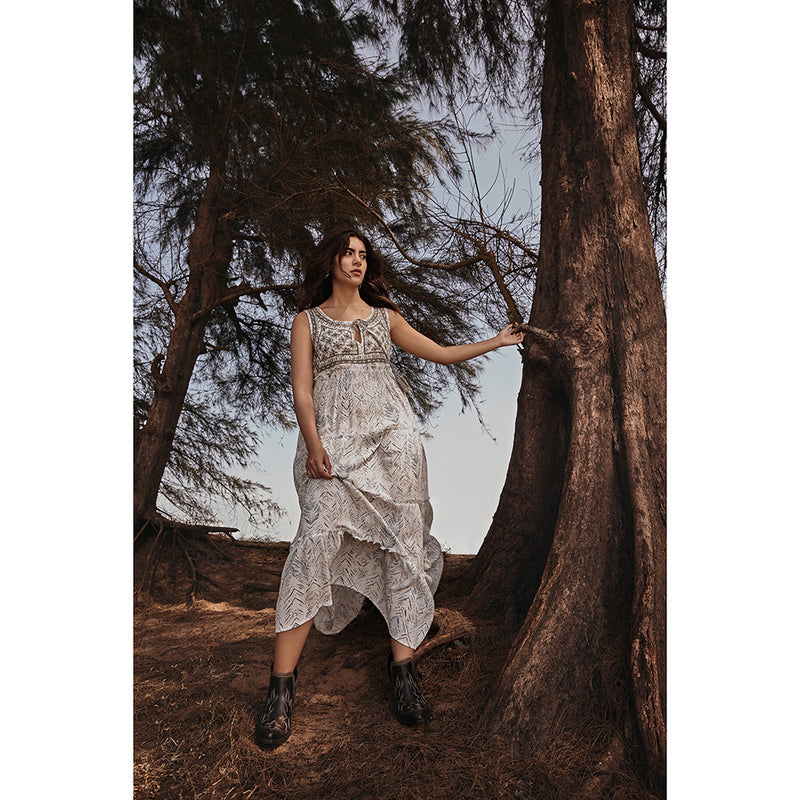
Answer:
[255,229,522,748]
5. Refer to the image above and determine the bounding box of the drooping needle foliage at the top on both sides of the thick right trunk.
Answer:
[370,0,667,282]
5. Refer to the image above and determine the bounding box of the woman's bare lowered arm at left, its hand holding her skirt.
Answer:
[290,313,333,478]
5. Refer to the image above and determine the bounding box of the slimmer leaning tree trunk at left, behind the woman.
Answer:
[133,171,233,526]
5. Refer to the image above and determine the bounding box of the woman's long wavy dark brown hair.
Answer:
[297,228,400,311]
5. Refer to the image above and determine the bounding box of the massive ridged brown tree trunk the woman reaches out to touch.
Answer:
[470,0,666,788]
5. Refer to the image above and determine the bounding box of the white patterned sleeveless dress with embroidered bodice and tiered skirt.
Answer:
[275,308,443,649]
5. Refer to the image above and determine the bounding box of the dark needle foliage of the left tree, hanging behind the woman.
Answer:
[134,0,496,519]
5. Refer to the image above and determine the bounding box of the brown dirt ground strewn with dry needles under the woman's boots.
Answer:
[134,540,649,800]
